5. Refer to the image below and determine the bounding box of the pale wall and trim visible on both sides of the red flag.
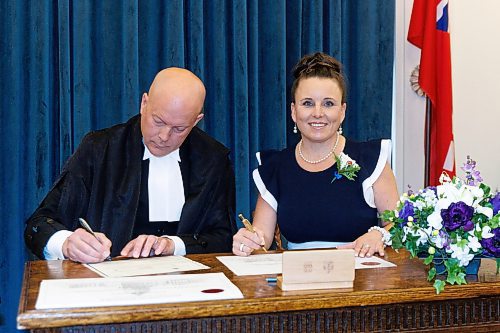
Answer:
[393,0,500,191]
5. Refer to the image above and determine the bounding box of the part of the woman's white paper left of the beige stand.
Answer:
[217,253,282,275]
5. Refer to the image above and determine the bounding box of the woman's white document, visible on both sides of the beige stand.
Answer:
[217,253,396,275]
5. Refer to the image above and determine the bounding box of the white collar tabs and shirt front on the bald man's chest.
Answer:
[144,146,185,222]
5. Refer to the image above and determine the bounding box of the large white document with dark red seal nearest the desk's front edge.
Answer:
[35,273,243,309]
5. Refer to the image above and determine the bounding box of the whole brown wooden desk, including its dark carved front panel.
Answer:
[17,249,500,332]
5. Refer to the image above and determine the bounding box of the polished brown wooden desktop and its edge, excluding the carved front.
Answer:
[17,249,500,329]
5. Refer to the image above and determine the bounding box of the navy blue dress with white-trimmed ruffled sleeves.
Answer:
[253,140,391,243]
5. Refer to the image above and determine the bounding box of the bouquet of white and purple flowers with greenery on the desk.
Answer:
[382,157,500,294]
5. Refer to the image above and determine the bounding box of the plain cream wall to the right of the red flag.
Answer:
[449,0,500,189]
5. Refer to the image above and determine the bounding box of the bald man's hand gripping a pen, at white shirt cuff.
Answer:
[62,228,111,264]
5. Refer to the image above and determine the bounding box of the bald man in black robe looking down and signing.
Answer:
[25,68,235,263]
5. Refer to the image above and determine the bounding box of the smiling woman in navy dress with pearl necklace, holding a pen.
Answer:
[233,53,399,257]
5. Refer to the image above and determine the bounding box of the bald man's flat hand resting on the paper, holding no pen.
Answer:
[120,235,175,258]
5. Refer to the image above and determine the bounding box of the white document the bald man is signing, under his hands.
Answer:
[85,256,210,277]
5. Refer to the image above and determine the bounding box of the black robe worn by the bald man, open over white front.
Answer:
[24,115,236,258]
